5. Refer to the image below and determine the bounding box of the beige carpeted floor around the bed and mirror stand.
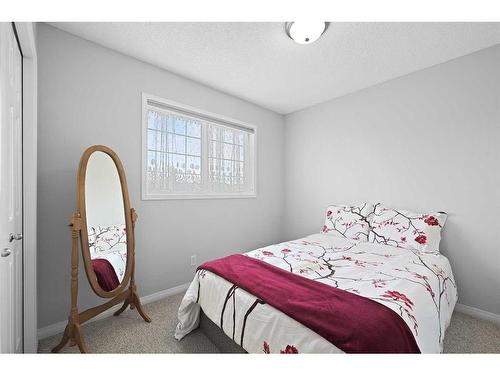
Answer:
[38,294,500,353]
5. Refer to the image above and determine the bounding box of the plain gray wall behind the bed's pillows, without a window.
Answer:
[284,45,500,314]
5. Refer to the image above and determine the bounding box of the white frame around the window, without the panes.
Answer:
[141,92,258,201]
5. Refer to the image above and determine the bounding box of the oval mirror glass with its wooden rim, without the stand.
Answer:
[78,146,133,298]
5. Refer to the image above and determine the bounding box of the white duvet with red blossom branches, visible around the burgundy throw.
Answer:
[175,234,457,353]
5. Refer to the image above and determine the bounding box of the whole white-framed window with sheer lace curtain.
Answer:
[142,94,255,199]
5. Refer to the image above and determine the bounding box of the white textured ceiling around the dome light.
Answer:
[47,22,500,114]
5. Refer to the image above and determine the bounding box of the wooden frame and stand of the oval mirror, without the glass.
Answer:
[52,145,151,353]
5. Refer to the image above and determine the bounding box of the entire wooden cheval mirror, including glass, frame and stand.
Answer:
[52,145,151,353]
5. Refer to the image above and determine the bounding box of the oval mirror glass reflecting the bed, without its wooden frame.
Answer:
[85,151,127,292]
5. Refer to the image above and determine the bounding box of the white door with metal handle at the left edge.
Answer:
[0,22,23,353]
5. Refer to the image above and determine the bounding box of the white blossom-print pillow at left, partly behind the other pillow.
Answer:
[321,203,373,242]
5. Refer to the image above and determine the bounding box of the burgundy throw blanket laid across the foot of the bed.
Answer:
[198,254,420,353]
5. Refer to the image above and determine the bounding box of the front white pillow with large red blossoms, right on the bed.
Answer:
[368,203,447,254]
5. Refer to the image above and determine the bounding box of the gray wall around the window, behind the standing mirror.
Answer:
[38,25,284,327]
